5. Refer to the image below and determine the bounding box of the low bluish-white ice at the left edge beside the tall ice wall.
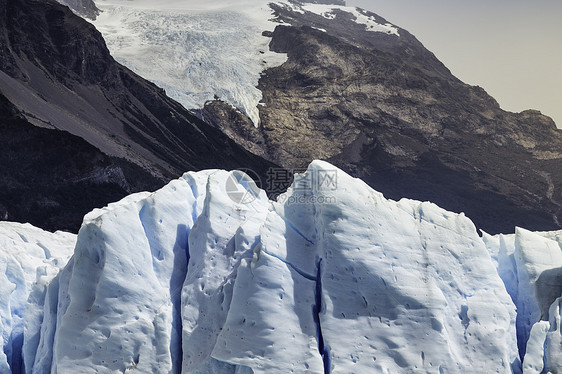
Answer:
[0,222,76,373]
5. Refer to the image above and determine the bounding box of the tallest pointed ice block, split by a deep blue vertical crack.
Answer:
[214,162,517,373]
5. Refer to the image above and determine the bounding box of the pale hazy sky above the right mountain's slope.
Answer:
[347,0,562,128]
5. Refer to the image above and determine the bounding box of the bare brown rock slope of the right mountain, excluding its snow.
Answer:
[202,5,562,233]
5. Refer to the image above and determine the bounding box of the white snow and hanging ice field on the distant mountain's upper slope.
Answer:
[66,0,398,126]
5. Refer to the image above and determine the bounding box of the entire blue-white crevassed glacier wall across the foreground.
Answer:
[0,161,562,374]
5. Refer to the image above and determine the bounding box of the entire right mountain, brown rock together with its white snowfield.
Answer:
[68,0,562,233]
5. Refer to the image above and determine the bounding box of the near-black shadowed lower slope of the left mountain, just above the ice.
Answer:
[0,96,153,231]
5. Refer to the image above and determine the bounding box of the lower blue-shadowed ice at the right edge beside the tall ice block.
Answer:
[483,228,562,373]
